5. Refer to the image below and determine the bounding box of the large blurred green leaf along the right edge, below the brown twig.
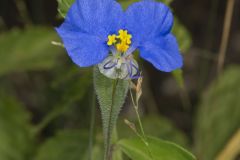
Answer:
[195,66,240,160]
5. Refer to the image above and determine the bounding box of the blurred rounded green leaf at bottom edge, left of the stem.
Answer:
[35,130,88,160]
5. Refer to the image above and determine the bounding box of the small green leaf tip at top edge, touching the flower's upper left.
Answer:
[57,0,75,18]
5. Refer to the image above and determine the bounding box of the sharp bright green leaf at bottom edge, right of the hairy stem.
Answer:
[118,137,196,160]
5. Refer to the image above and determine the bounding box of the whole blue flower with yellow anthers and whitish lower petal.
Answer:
[56,0,182,79]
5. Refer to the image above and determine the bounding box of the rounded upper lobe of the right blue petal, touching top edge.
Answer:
[126,0,173,43]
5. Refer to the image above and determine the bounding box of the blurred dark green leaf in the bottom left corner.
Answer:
[0,92,33,160]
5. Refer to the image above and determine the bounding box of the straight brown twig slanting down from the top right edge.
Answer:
[217,0,235,74]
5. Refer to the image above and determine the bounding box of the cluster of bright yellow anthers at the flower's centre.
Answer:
[107,29,132,53]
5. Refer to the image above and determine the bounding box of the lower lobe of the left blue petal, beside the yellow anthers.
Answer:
[56,22,109,67]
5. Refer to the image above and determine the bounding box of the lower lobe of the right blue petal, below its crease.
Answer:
[139,34,183,72]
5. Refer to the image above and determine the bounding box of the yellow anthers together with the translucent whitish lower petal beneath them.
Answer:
[98,29,140,79]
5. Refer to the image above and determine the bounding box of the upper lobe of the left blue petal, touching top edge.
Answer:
[66,0,123,38]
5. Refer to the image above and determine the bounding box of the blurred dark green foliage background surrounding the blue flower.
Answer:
[0,0,240,160]
